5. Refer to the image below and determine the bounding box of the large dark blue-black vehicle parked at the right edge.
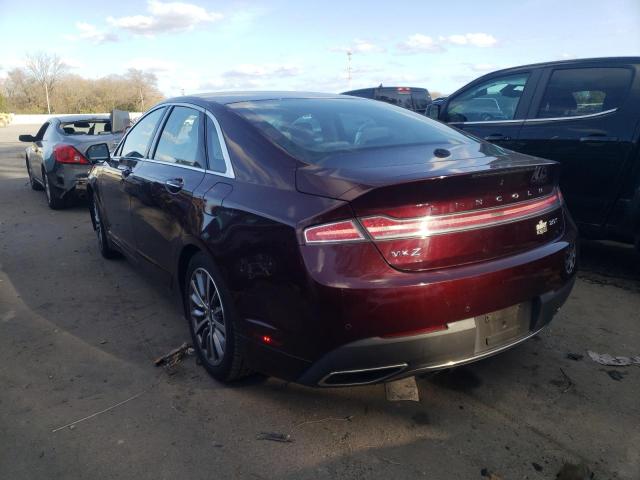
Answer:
[429,57,640,248]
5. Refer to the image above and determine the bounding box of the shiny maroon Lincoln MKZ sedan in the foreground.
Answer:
[87,92,576,386]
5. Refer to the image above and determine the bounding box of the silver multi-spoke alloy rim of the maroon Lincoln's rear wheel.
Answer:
[189,267,227,366]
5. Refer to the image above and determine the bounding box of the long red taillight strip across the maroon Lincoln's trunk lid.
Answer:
[360,191,561,240]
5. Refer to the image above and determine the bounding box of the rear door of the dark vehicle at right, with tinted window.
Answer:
[519,64,638,226]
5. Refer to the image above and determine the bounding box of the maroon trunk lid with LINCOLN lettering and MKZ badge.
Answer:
[299,144,564,271]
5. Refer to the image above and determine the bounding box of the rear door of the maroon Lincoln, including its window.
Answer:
[131,105,206,284]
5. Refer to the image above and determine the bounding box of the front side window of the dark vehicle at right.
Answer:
[446,73,529,122]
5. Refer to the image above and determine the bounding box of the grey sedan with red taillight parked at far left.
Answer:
[19,115,122,209]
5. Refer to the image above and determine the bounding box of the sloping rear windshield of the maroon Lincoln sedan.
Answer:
[228,97,472,163]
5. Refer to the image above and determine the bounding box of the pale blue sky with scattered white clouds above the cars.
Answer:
[0,0,640,96]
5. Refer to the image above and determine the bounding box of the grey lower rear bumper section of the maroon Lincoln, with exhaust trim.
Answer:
[296,277,575,387]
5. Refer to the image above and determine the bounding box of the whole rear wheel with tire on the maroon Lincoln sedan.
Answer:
[183,252,251,382]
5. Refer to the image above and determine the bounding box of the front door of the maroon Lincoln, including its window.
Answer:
[99,107,166,256]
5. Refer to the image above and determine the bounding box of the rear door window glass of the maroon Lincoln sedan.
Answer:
[153,107,204,168]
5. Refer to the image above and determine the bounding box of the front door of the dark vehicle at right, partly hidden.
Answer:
[440,69,540,150]
